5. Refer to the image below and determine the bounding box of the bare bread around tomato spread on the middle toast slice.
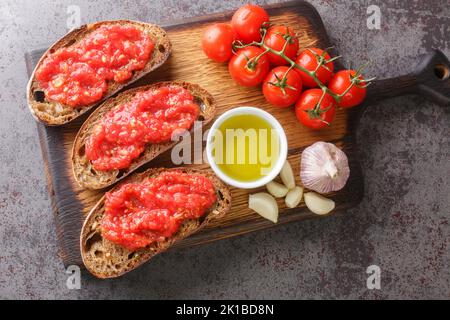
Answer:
[72,82,216,189]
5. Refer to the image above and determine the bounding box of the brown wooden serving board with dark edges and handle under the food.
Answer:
[26,1,450,266]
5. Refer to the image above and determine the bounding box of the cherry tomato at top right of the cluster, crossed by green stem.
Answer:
[264,26,298,66]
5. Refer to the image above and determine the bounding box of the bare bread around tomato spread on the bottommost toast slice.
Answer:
[80,168,231,278]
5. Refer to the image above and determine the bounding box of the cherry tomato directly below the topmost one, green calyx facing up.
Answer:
[228,46,270,87]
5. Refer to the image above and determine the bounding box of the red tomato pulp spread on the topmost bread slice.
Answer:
[35,25,154,108]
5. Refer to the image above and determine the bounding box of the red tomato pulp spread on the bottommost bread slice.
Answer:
[101,170,217,251]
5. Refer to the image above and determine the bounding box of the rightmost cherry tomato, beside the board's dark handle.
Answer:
[328,70,367,108]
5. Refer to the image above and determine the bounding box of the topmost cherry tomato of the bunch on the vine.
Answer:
[231,4,269,43]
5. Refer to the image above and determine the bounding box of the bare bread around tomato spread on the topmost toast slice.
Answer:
[27,20,172,126]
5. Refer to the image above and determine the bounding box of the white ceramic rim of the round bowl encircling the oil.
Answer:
[206,107,288,189]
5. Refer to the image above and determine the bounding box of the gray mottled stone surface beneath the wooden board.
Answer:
[0,0,450,299]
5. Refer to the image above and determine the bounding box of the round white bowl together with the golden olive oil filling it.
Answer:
[207,107,287,188]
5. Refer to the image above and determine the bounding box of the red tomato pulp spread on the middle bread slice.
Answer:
[85,86,200,171]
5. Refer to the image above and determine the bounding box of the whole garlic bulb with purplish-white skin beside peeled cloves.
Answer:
[300,141,350,193]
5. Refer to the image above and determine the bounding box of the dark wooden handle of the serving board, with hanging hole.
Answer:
[366,49,450,106]
